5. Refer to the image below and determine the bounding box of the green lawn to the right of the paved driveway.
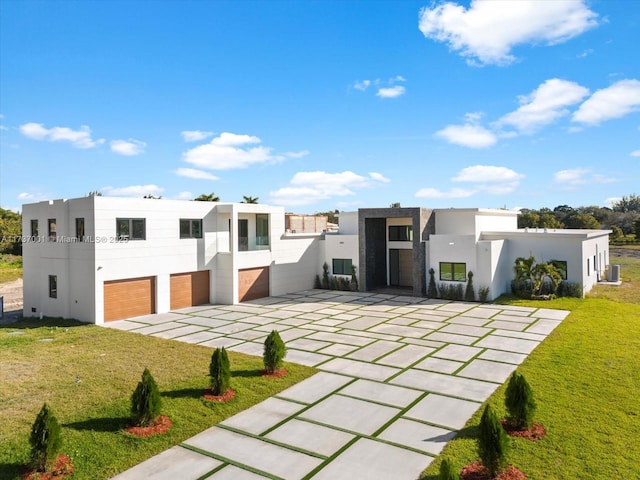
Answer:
[421,253,640,480]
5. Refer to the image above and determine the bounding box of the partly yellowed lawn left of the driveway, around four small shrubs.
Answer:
[0,319,314,480]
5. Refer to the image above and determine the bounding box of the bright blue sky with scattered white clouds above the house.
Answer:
[0,0,640,213]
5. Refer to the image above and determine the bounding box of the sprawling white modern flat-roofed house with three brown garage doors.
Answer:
[22,196,610,324]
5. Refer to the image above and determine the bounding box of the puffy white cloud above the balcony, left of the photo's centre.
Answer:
[182,132,285,170]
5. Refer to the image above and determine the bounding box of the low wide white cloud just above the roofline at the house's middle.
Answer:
[269,171,389,205]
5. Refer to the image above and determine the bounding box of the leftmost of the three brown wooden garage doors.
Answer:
[104,277,156,322]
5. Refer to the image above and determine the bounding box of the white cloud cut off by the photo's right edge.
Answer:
[572,79,640,125]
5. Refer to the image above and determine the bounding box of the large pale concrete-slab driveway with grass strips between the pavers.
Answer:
[105,290,569,480]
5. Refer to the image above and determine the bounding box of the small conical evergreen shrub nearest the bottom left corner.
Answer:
[29,403,62,472]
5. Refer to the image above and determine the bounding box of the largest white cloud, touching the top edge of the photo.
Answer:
[418,0,598,65]
